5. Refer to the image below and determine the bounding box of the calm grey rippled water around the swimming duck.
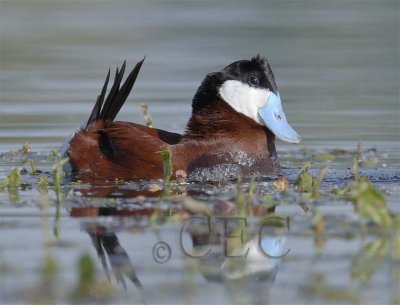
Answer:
[0,0,400,304]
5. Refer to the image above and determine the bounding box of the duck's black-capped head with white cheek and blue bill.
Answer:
[192,55,301,143]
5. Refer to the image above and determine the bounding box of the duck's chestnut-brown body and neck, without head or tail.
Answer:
[69,103,278,182]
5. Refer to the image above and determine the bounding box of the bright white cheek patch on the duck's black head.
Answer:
[219,80,270,125]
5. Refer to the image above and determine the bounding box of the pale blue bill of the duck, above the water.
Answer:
[258,92,301,144]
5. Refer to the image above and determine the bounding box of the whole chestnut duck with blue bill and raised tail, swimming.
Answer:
[66,56,301,182]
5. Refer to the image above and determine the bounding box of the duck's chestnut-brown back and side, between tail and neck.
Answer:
[69,121,181,182]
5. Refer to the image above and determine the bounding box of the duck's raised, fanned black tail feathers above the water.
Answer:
[86,57,146,128]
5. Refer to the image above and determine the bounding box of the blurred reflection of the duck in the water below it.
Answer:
[70,201,288,304]
